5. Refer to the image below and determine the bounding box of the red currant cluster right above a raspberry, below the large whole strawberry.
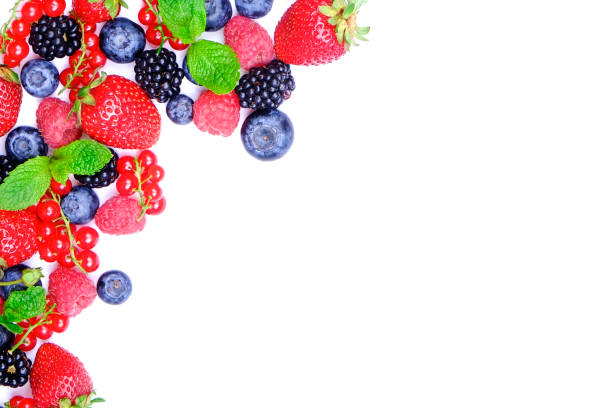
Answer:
[115,150,166,217]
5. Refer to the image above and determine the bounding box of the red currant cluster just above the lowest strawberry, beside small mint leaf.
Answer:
[15,296,70,351]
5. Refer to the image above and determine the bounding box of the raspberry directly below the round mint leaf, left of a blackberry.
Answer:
[193,91,240,137]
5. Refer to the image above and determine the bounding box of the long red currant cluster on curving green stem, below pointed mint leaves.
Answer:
[36,180,100,273]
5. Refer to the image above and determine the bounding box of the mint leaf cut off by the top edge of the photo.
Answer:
[158,0,206,44]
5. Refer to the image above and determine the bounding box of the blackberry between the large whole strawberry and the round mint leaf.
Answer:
[134,48,185,103]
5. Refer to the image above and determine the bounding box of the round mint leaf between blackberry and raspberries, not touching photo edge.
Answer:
[187,40,240,95]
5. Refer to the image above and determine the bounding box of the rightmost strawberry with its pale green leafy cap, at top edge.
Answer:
[274,0,370,65]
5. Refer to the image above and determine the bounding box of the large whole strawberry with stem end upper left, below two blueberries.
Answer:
[77,75,161,149]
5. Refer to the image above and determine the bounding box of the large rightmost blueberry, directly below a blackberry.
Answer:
[240,109,293,161]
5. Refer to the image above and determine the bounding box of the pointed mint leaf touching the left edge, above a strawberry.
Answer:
[0,156,51,211]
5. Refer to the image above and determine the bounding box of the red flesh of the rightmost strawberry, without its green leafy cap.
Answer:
[274,0,346,65]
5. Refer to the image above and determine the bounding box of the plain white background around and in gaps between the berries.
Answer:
[0,0,612,408]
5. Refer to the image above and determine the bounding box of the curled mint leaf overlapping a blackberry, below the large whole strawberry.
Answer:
[50,140,113,184]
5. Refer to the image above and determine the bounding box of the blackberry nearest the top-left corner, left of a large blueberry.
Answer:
[28,16,81,61]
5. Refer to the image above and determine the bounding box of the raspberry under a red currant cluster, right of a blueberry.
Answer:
[95,196,146,235]
